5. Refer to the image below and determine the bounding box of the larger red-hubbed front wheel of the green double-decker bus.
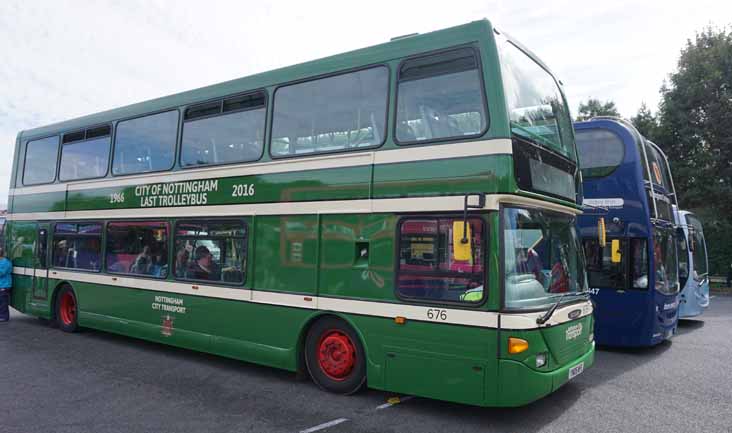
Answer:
[305,317,366,395]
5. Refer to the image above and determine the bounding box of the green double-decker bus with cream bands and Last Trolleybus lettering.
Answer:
[5,20,594,406]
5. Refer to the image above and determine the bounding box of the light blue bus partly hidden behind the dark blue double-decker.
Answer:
[676,210,709,319]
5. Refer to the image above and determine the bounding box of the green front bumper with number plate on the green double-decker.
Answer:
[496,342,595,407]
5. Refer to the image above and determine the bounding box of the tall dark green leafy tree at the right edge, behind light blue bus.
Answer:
[656,27,732,275]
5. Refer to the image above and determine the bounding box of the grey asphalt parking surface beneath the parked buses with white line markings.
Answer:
[0,296,732,433]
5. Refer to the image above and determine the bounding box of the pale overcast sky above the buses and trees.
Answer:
[0,0,732,204]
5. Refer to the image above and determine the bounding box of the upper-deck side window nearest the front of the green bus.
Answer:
[396,48,487,143]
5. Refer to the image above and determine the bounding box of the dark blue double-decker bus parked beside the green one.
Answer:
[574,118,679,346]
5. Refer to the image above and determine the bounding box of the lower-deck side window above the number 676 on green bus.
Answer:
[397,218,484,303]
